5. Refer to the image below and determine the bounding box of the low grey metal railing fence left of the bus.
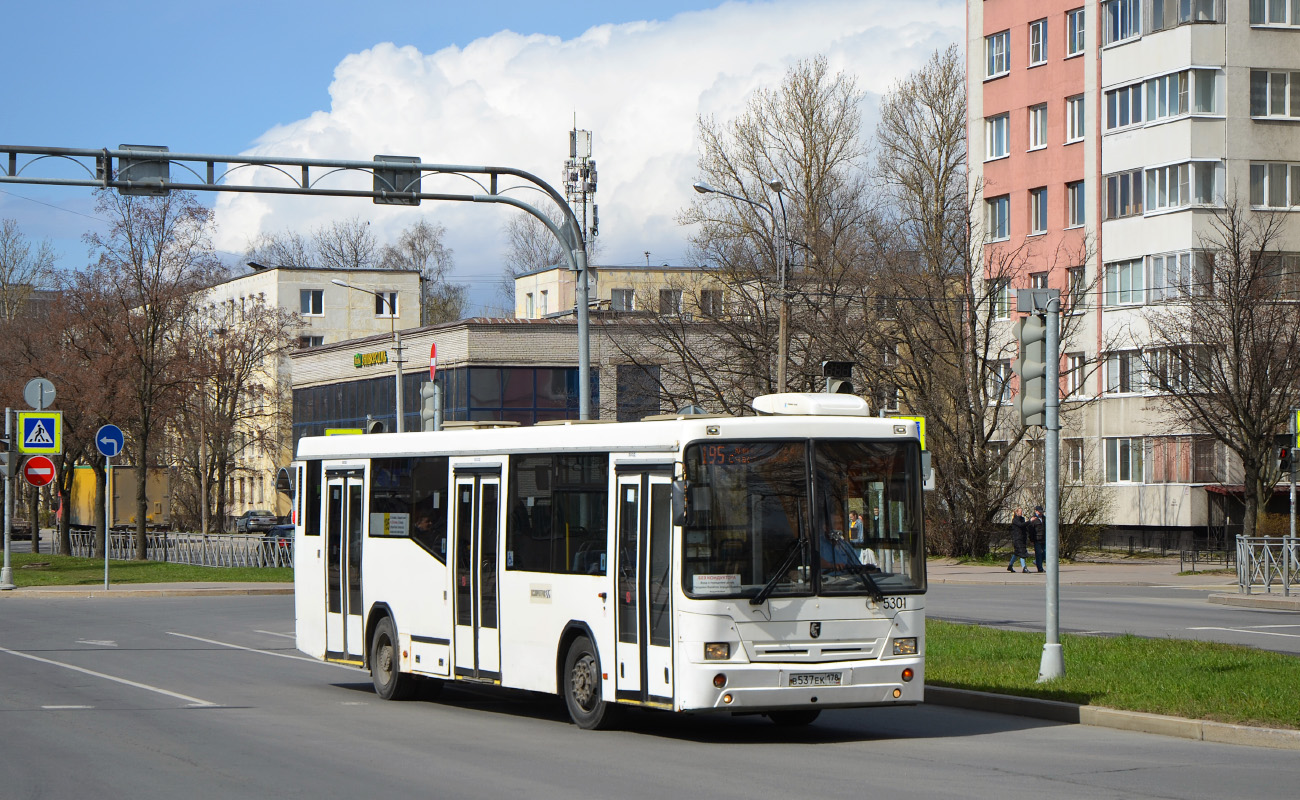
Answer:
[72,531,294,567]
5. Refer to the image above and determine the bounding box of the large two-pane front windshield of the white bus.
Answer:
[681,440,926,598]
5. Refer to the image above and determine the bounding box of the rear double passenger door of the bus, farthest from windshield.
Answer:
[325,470,365,663]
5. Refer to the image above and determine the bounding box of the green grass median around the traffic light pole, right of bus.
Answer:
[926,619,1300,728]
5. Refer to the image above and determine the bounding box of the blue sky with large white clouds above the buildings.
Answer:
[0,0,963,312]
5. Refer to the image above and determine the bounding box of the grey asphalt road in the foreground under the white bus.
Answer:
[0,596,1296,800]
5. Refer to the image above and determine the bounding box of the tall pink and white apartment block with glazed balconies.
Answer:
[967,0,1300,544]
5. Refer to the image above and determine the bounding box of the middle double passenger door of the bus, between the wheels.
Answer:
[451,472,501,680]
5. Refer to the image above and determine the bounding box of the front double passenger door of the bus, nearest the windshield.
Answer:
[615,472,672,704]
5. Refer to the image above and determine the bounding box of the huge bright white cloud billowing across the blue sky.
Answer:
[216,0,963,313]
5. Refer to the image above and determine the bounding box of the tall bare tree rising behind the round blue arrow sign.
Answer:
[81,190,220,559]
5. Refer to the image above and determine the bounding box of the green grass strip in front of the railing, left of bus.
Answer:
[10,553,294,587]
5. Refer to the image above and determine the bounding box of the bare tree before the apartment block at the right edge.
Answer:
[1141,194,1300,535]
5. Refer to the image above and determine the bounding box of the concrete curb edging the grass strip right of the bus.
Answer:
[926,686,1300,751]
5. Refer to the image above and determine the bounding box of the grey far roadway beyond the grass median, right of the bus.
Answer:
[926,584,1300,654]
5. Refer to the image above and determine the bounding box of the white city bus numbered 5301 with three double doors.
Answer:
[294,394,926,728]
